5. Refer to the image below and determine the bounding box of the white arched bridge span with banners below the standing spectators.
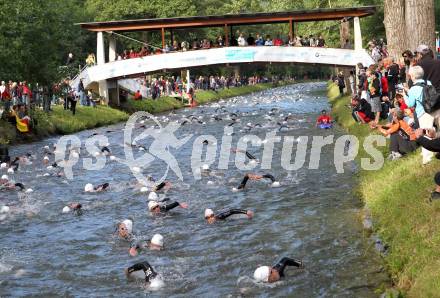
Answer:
[72,46,373,88]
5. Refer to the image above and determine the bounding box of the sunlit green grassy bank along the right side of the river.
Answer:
[328,84,440,297]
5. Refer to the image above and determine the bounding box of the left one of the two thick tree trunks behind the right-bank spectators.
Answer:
[384,0,407,59]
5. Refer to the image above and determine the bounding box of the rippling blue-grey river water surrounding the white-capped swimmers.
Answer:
[0,83,389,297]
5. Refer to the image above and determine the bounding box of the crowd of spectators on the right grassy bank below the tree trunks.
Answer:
[344,45,440,172]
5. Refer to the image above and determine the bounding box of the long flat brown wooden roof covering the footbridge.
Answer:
[78,6,376,31]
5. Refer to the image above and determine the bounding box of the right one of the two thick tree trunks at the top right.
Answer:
[406,0,435,51]
